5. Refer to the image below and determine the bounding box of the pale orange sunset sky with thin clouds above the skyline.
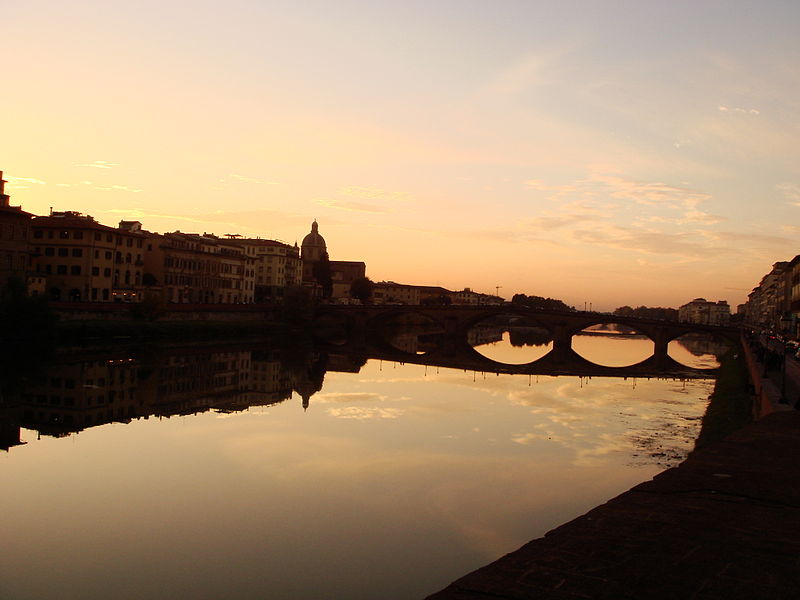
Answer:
[0,0,800,310]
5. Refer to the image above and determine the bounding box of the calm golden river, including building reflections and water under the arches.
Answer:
[0,337,713,600]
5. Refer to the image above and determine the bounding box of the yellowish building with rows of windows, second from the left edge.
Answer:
[30,211,144,302]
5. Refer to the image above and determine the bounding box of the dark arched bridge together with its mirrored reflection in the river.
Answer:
[317,306,740,379]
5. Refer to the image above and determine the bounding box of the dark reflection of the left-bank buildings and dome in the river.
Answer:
[0,348,359,450]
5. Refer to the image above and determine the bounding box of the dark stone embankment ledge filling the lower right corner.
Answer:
[428,340,800,600]
